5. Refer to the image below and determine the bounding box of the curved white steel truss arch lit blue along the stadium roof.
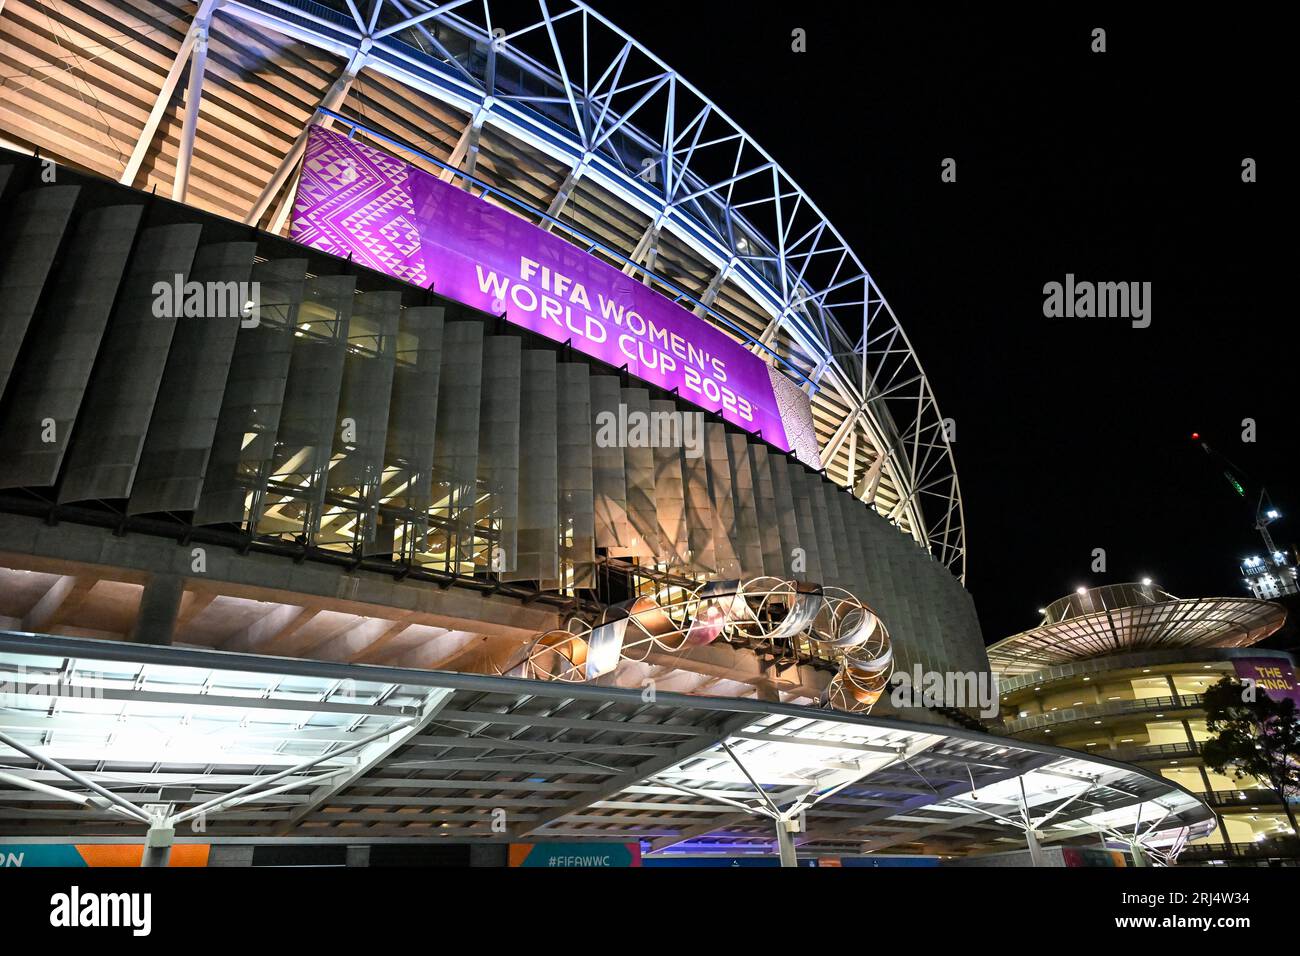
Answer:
[178,0,966,580]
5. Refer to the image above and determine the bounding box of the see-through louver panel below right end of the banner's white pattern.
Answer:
[320,291,402,553]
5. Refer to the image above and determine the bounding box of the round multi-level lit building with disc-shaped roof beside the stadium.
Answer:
[989,584,1297,862]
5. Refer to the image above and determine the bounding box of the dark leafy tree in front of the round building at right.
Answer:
[1201,678,1300,836]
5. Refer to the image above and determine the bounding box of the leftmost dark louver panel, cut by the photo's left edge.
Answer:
[0,184,81,394]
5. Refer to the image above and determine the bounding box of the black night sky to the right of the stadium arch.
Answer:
[598,3,1300,641]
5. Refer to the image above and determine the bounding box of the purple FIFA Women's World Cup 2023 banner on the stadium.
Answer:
[291,126,790,451]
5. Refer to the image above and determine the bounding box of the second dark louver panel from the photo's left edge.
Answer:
[0,206,142,488]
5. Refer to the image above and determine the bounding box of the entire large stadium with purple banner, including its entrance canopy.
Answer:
[0,0,1213,862]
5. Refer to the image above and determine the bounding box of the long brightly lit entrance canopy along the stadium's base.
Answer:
[0,632,1213,855]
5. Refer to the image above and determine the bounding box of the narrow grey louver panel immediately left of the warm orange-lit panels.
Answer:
[559,362,595,588]
